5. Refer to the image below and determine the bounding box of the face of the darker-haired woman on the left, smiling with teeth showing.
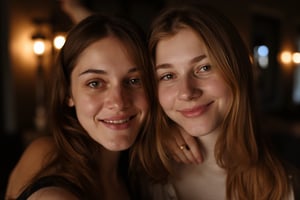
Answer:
[69,37,148,151]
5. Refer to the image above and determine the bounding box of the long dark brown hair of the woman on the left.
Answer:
[30,14,155,199]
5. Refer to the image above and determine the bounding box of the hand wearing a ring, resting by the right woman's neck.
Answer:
[165,127,202,164]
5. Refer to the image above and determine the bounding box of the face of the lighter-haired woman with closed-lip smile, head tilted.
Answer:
[156,28,232,136]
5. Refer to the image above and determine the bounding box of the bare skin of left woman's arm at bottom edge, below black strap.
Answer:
[28,187,79,200]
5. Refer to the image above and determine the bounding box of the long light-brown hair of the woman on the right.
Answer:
[144,5,290,200]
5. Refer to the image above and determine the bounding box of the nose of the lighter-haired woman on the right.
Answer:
[178,76,202,101]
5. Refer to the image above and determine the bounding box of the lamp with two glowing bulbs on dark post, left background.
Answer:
[31,18,65,133]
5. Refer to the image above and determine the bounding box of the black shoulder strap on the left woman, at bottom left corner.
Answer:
[16,175,82,200]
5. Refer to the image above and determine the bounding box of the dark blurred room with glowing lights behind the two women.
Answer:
[0,0,300,198]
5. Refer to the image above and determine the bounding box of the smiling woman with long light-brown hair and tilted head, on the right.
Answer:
[140,4,299,200]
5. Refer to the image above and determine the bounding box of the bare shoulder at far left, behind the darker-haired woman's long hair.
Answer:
[6,136,55,198]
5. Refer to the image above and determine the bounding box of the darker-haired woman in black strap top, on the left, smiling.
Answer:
[6,15,156,200]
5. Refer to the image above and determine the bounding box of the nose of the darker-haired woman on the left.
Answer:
[106,86,130,110]
